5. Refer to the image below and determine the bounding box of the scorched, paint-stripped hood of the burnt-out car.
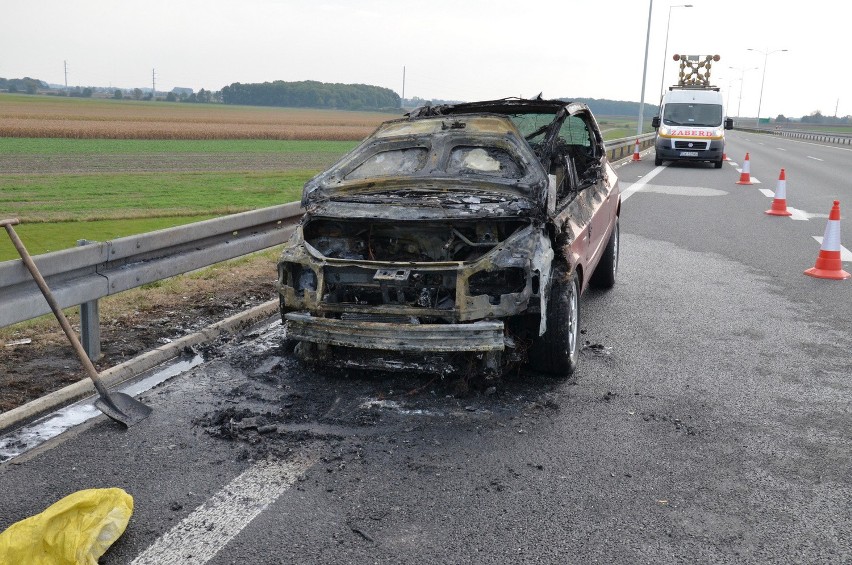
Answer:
[302,113,548,207]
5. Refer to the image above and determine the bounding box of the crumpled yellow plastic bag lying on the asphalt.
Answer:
[0,488,133,565]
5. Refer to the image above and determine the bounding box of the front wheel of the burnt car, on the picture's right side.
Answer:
[528,269,580,378]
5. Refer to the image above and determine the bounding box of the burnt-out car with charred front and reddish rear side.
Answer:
[277,98,621,376]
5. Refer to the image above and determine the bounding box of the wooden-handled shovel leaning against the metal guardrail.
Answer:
[0,218,151,426]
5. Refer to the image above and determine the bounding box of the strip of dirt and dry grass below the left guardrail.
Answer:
[0,251,277,413]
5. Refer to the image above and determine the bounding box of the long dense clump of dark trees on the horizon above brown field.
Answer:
[222,80,401,110]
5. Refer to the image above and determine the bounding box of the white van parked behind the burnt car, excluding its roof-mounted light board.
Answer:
[651,86,734,169]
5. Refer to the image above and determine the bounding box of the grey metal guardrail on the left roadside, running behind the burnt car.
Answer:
[0,137,654,359]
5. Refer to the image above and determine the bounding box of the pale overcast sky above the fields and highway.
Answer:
[0,0,852,117]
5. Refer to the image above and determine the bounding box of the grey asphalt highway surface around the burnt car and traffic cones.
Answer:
[0,132,852,564]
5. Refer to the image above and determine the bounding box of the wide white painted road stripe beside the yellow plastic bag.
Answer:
[132,460,313,565]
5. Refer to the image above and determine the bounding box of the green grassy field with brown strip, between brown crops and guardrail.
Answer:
[0,138,357,261]
